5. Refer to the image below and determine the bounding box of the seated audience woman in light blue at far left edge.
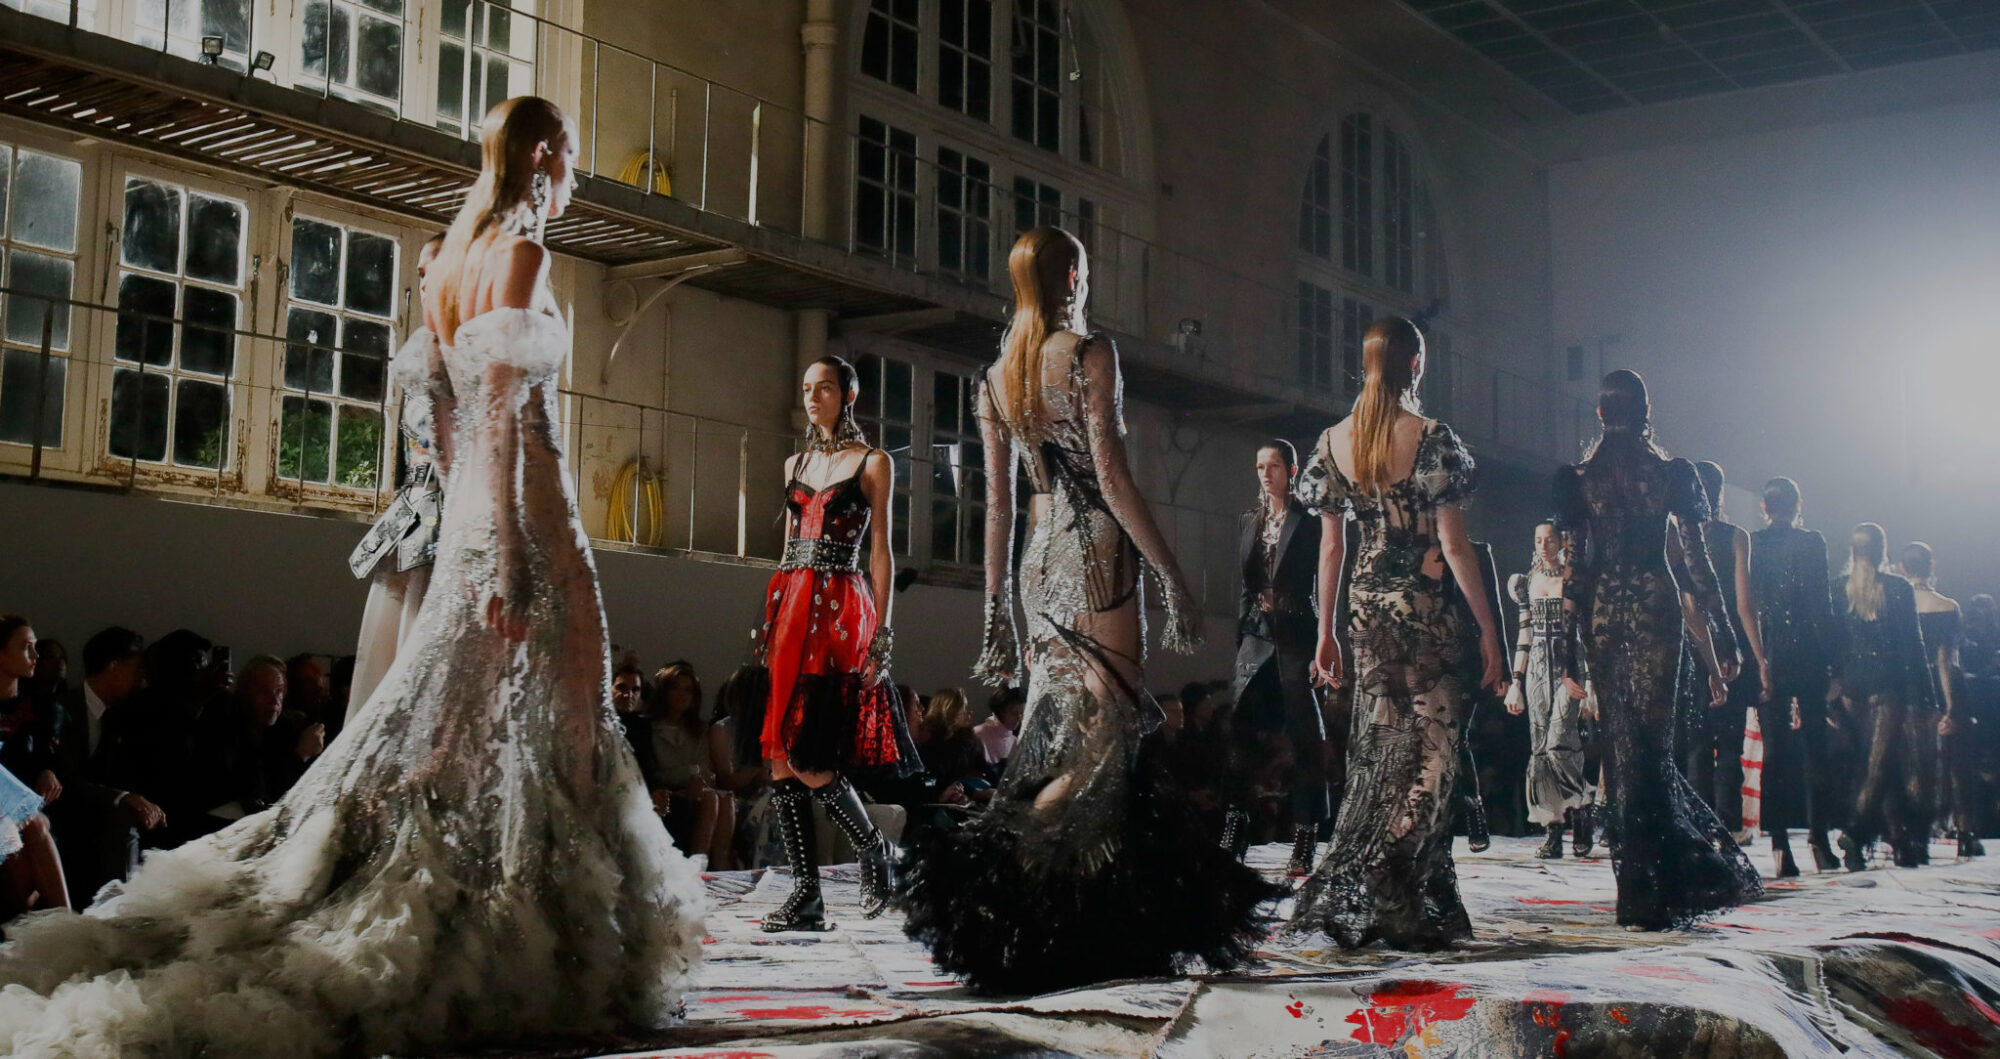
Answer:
[0,615,70,919]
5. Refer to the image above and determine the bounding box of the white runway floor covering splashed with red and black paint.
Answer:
[454,837,2000,1059]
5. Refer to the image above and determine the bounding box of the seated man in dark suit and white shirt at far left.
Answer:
[48,625,166,911]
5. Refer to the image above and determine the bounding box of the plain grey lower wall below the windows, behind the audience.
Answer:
[0,482,1232,697]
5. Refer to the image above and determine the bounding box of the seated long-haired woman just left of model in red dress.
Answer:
[646,661,736,871]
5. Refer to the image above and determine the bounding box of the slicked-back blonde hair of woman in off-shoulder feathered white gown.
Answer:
[426,96,570,342]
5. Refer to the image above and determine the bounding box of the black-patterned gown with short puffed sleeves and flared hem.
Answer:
[1286,422,1476,949]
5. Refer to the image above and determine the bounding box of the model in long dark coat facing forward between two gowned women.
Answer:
[1234,440,1332,875]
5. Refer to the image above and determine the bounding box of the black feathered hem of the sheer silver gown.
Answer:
[902,753,1278,993]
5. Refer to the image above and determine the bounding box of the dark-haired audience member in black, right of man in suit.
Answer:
[96,629,232,849]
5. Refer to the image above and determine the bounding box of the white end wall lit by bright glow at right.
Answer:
[1550,100,2000,597]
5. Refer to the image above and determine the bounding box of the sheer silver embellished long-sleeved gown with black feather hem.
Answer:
[904,336,1274,993]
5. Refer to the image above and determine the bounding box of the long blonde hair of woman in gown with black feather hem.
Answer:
[994,226,1084,440]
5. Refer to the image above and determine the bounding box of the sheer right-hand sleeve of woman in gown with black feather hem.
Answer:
[1072,336,1200,651]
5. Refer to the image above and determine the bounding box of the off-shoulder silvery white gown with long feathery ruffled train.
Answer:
[0,310,704,1057]
